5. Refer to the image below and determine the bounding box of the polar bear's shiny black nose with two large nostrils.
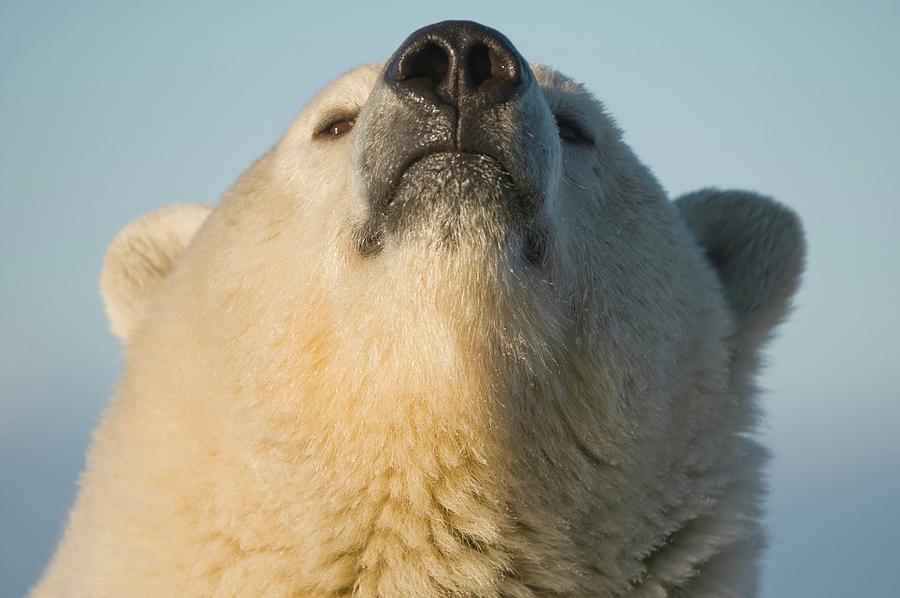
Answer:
[385,21,531,106]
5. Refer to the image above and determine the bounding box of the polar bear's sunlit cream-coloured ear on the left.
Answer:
[100,204,212,341]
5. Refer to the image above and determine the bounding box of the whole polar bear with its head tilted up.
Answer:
[33,21,804,598]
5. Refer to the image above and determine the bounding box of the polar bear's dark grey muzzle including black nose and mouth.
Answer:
[353,21,561,262]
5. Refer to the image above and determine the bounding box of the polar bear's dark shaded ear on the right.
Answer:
[675,189,806,348]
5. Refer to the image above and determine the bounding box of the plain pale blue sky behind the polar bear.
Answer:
[0,0,900,598]
